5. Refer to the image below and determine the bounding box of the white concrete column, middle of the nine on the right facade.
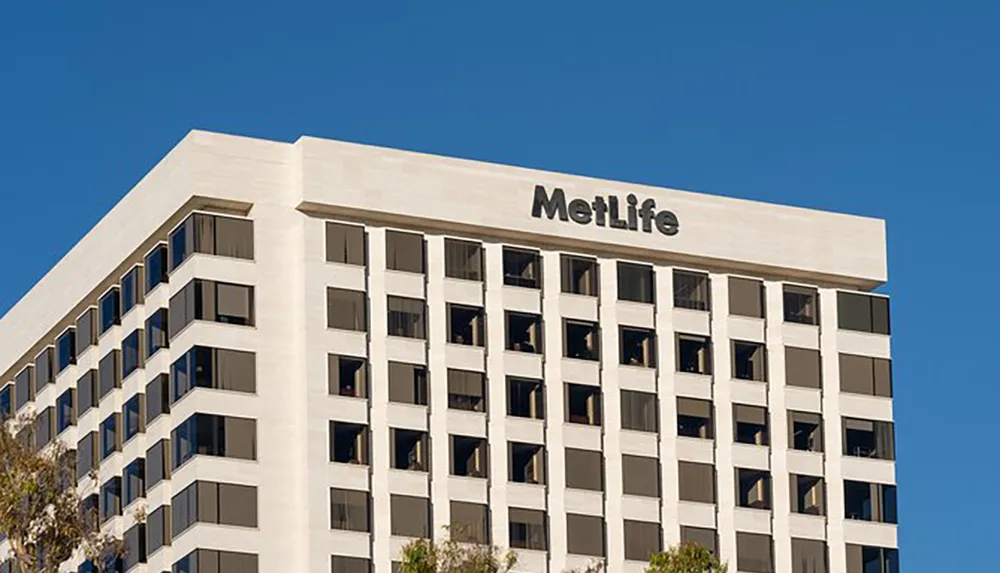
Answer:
[598,258,625,564]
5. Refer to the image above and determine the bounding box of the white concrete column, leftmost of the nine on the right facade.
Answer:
[368,227,395,571]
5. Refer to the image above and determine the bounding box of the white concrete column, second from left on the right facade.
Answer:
[427,235,451,536]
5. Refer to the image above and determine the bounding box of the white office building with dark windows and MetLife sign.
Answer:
[0,132,899,573]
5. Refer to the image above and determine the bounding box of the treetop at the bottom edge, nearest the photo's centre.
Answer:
[400,528,517,573]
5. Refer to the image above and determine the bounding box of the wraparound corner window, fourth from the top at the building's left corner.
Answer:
[170,413,257,469]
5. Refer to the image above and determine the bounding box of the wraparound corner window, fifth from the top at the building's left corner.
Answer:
[170,481,257,539]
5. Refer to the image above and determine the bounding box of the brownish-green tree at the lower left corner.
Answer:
[0,416,129,573]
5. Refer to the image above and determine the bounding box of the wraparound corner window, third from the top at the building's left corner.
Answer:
[170,346,257,404]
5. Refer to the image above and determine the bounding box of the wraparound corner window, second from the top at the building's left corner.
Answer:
[168,279,254,338]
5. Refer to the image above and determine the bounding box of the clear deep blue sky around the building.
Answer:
[0,0,1000,573]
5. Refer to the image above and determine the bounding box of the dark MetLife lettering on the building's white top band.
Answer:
[531,185,680,236]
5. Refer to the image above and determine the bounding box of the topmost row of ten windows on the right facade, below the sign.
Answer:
[326,222,889,334]
